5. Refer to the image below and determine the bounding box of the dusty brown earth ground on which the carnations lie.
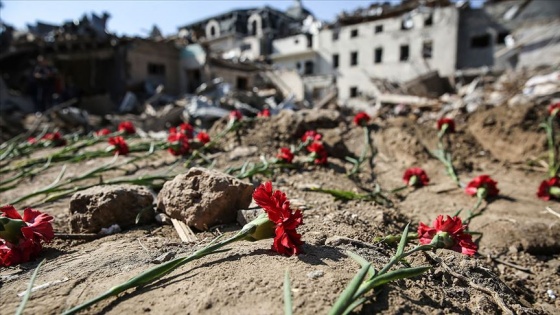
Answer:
[0,105,560,314]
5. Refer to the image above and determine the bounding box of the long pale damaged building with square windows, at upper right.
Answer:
[270,0,560,102]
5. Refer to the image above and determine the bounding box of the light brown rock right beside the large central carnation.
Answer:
[157,167,253,231]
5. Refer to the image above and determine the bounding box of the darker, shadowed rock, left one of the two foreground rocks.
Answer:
[70,185,154,233]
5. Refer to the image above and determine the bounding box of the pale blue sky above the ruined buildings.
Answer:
[0,0,483,36]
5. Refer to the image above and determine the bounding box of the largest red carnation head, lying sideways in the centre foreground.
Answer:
[253,182,303,256]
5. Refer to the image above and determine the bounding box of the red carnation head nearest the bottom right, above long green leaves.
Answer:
[418,215,477,256]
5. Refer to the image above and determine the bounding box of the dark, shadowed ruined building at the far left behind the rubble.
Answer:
[0,14,180,114]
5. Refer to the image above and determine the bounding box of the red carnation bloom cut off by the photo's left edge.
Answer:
[0,205,54,267]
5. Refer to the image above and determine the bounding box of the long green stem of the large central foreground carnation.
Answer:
[63,216,268,315]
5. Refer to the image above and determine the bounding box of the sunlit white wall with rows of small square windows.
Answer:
[316,6,459,100]
